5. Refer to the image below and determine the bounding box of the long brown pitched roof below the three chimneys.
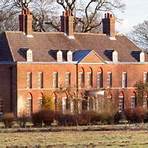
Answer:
[0,32,148,62]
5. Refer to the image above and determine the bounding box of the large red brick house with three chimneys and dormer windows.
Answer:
[0,9,148,115]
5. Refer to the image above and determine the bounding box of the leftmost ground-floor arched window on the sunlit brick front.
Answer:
[26,94,33,116]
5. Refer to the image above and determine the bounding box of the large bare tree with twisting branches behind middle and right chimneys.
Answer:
[57,0,125,32]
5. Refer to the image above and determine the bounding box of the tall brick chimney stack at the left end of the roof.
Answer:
[19,8,33,35]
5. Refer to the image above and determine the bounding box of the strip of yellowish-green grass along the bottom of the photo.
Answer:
[0,131,148,148]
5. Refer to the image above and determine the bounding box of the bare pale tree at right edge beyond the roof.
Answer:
[128,21,148,49]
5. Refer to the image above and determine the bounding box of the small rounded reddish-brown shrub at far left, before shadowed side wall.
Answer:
[2,113,15,128]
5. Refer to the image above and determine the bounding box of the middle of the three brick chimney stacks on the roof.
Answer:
[61,10,74,37]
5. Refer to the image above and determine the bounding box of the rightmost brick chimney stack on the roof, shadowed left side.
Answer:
[102,13,116,37]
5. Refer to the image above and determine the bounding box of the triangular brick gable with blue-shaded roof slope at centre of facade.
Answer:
[74,50,104,63]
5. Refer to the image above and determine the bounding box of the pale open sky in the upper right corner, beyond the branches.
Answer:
[117,0,148,33]
